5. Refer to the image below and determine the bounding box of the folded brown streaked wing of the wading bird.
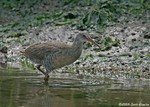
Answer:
[25,42,70,60]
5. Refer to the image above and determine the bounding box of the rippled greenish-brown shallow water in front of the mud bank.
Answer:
[0,68,150,107]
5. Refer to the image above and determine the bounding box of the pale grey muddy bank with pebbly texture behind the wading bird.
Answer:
[0,22,150,78]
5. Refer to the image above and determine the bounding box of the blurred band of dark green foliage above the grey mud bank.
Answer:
[0,0,150,32]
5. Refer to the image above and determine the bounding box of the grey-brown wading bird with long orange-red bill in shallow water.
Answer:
[21,33,100,82]
